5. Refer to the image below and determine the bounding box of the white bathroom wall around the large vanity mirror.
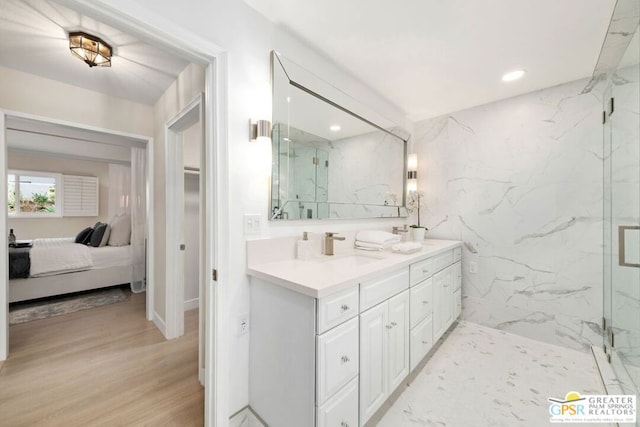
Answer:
[98,0,406,413]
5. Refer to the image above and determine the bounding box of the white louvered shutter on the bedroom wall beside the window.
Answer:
[62,175,99,216]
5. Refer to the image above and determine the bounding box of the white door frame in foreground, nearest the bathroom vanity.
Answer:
[0,0,230,427]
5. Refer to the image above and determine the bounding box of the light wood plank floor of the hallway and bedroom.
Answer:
[0,294,204,427]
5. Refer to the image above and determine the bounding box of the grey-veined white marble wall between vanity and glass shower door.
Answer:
[413,79,603,350]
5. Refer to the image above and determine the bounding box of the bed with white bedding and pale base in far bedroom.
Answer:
[9,238,133,303]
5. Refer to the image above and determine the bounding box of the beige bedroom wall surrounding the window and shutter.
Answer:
[7,151,109,239]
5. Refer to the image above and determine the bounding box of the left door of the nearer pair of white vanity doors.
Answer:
[360,302,391,425]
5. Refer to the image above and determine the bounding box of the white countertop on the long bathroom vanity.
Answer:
[247,239,462,298]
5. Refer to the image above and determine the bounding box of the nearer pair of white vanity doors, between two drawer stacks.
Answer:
[360,283,409,425]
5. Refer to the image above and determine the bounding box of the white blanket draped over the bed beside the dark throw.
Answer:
[29,238,93,277]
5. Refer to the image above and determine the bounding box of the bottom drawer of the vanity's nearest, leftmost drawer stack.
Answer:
[316,377,358,427]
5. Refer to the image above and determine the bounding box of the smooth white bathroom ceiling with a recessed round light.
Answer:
[245,0,615,120]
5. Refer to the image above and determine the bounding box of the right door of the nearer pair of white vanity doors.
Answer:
[387,290,410,393]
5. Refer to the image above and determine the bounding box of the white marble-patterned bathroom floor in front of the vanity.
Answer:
[377,321,604,427]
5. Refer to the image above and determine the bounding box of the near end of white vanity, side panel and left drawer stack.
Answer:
[249,278,360,427]
